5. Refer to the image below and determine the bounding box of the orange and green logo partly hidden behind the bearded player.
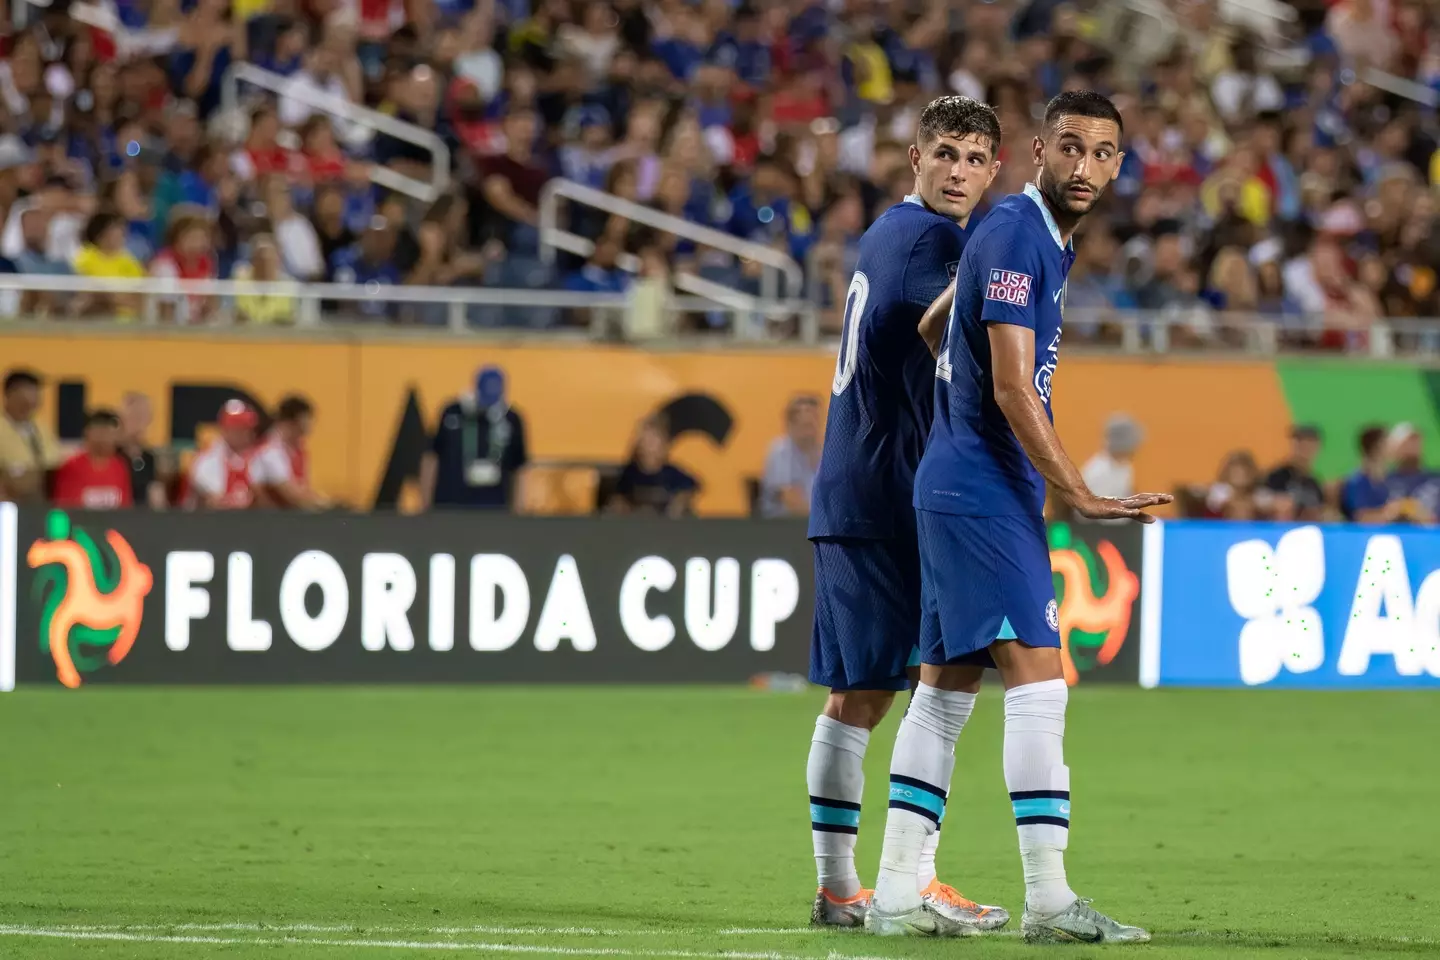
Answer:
[1050,524,1140,687]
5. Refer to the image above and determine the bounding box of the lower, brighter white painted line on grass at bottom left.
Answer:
[0,924,891,960]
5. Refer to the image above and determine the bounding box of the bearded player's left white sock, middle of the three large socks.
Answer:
[874,684,975,914]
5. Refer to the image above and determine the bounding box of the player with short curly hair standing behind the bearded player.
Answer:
[806,96,1009,928]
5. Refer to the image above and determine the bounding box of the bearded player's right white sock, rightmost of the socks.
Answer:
[1005,679,1076,917]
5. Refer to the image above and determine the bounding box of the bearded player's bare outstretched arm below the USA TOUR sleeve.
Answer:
[989,324,1174,524]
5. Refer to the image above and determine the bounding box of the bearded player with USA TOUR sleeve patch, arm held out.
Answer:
[865,92,1171,943]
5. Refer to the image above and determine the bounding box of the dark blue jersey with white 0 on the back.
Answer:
[809,197,966,540]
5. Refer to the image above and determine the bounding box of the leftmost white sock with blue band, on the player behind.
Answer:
[805,715,870,900]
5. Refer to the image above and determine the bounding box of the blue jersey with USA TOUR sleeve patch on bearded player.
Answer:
[914,184,1074,517]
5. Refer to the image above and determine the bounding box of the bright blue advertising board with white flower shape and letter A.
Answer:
[1140,521,1440,688]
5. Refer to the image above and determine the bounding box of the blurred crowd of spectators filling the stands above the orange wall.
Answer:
[0,0,1440,341]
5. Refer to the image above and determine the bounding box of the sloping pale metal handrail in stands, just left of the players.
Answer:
[540,178,819,343]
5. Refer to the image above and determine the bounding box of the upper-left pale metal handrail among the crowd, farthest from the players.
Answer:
[220,63,451,203]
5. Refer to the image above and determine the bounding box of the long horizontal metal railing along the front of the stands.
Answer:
[0,273,1440,358]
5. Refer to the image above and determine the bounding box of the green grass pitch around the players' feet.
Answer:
[0,688,1440,960]
